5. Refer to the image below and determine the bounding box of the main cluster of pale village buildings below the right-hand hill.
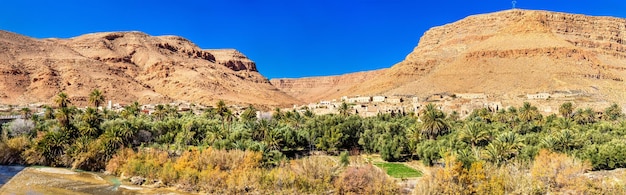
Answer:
[292,91,610,118]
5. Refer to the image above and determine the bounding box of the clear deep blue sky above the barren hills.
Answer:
[0,0,626,78]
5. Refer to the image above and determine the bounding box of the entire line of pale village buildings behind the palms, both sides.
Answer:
[0,91,610,119]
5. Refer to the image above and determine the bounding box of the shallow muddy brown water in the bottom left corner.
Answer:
[0,166,193,195]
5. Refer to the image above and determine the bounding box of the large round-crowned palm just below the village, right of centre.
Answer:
[421,104,449,139]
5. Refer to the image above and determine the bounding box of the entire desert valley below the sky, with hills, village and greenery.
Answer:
[0,9,626,194]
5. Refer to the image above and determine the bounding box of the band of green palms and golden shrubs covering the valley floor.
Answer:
[0,90,626,194]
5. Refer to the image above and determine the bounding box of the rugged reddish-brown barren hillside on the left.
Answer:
[0,31,299,106]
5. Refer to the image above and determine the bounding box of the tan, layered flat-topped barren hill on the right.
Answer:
[272,10,626,103]
